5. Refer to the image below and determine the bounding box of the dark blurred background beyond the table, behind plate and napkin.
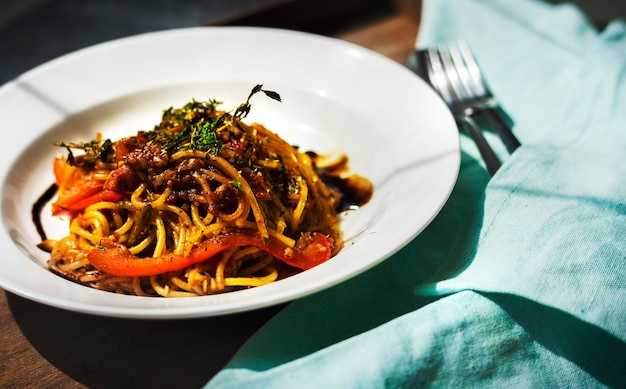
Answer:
[0,0,626,85]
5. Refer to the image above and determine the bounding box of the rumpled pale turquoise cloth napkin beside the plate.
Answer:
[207,0,626,388]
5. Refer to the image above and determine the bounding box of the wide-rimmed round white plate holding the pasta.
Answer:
[0,27,460,318]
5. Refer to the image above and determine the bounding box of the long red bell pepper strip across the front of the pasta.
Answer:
[88,230,333,277]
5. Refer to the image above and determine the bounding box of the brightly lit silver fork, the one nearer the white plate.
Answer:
[407,44,501,176]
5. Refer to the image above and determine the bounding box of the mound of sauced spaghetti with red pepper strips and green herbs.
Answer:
[40,85,371,297]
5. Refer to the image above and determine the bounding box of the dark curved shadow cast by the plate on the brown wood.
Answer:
[7,293,283,388]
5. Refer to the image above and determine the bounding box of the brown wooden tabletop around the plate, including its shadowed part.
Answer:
[0,1,419,388]
